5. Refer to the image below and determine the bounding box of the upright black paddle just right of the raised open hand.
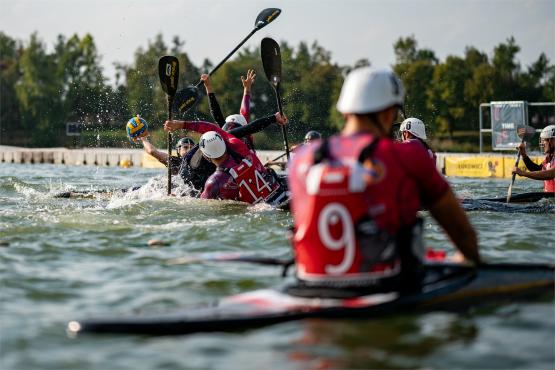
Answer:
[260,37,289,160]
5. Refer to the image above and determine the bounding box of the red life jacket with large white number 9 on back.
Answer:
[293,139,424,287]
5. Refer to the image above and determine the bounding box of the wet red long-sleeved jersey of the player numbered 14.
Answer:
[184,121,285,204]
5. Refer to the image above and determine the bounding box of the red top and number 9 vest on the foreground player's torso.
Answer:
[289,133,449,286]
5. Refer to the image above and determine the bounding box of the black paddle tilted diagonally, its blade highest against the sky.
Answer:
[170,8,281,113]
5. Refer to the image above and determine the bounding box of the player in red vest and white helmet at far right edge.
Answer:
[513,125,555,193]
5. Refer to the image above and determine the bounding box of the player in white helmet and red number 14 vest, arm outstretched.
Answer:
[164,112,287,206]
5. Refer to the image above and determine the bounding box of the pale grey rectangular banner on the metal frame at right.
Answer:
[490,101,528,150]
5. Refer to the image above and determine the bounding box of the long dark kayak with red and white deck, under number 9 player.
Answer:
[67,263,555,336]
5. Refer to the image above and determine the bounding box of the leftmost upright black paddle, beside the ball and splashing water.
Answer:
[158,55,179,195]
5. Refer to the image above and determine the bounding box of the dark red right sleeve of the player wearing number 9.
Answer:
[396,142,449,206]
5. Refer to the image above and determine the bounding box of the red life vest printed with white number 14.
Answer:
[228,158,281,204]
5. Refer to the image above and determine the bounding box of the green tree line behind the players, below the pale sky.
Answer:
[0,32,555,149]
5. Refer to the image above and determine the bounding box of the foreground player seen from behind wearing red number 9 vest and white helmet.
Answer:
[289,68,480,291]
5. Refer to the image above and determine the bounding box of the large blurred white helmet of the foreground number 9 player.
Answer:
[337,67,405,114]
